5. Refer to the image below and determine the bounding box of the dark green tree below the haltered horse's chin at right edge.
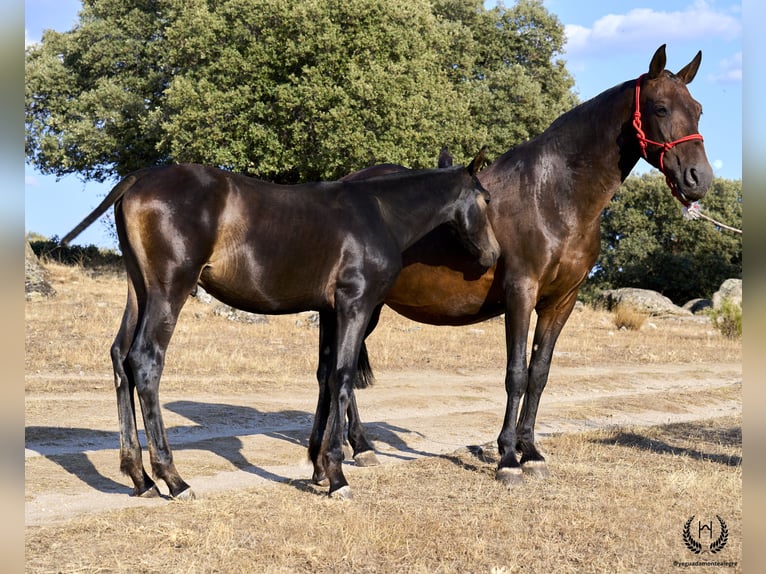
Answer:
[584,171,742,304]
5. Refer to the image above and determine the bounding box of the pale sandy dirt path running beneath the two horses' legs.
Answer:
[25,363,742,526]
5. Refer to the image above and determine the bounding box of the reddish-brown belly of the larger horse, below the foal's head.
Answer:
[385,263,504,325]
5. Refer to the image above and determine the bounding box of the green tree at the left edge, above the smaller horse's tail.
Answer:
[25,0,168,181]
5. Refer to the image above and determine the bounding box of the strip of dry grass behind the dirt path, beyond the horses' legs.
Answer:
[25,264,742,392]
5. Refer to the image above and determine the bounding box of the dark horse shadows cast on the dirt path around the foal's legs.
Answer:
[24,400,435,494]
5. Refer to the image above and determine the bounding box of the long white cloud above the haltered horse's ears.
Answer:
[564,0,742,56]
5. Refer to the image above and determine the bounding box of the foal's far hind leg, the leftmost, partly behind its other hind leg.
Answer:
[111,281,159,497]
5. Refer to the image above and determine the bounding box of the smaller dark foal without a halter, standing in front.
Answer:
[62,153,499,498]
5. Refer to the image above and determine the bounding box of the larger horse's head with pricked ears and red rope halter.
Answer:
[633,44,713,205]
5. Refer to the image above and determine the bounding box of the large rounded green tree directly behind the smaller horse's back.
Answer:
[165,0,479,182]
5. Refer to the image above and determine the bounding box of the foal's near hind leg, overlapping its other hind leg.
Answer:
[127,290,194,498]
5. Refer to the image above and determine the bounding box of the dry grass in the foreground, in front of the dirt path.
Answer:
[26,419,742,574]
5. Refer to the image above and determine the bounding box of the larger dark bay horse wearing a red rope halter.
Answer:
[346,45,712,486]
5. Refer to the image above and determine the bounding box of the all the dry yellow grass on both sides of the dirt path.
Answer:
[25,265,742,574]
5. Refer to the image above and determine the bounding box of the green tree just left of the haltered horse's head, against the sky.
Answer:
[434,0,572,155]
